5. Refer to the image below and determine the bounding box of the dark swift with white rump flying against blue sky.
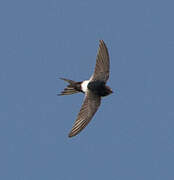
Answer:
[58,40,113,137]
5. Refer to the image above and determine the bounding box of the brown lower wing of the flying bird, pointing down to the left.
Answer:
[68,91,101,137]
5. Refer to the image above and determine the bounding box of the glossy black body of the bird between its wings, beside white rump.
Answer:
[88,81,108,96]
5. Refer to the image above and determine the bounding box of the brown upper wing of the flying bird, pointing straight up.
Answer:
[90,40,110,82]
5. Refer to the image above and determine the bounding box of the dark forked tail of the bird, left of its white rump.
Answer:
[58,78,79,96]
